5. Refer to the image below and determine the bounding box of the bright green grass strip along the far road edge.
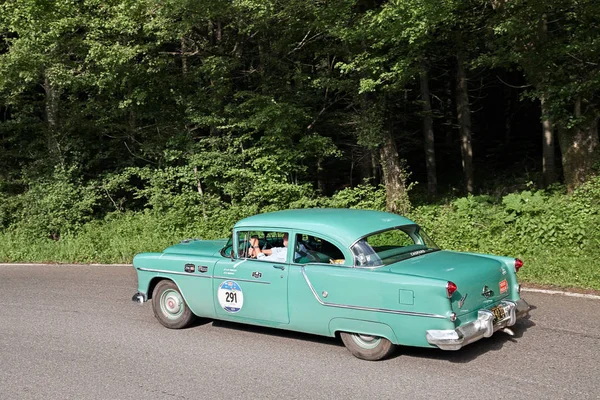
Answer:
[0,209,600,290]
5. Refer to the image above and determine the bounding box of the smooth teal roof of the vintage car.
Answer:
[234,208,415,246]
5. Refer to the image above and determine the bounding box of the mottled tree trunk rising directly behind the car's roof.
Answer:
[380,129,410,214]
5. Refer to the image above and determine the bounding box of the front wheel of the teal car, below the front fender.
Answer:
[152,280,196,329]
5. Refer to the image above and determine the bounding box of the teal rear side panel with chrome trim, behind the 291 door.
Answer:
[289,264,454,347]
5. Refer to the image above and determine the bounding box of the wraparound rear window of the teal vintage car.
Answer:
[352,225,440,267]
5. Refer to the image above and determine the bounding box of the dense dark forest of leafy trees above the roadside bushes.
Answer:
[0,0,600,288]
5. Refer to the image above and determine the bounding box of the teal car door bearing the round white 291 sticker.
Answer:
[213,230,290,324]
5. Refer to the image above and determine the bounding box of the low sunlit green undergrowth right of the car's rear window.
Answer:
[412,177,600,289]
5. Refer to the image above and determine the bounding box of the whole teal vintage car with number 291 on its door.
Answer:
[133,209,529,360]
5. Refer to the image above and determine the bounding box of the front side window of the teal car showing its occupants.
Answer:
[237,231,288,262]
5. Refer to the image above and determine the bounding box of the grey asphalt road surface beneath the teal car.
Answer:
[0,265,600,400]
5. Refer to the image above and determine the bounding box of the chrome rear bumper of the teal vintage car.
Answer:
[427,299,529,350]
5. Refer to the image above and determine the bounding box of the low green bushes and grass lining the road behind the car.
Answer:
[0,172,600,290]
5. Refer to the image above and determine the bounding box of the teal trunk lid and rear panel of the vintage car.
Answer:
[389,250,509,315]
